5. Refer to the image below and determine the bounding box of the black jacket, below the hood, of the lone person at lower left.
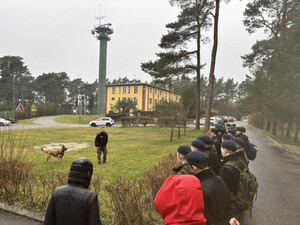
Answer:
[44,183,102,225]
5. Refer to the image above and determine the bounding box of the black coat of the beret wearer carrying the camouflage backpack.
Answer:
[218,153,246,195]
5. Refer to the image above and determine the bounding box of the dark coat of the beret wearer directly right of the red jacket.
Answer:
[196,169,234,225]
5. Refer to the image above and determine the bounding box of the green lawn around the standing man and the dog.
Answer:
[11,127,199,180]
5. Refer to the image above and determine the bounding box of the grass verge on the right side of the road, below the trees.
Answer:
[255,127,300,155]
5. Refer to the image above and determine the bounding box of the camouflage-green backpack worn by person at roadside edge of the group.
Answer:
[225,162,258,212]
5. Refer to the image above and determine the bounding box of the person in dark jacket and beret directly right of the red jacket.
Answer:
[187,151,238,225]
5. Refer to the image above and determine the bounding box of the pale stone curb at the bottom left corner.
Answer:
[0,202,45,222]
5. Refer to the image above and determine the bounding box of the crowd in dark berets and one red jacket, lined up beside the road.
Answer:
[154,124,256,225]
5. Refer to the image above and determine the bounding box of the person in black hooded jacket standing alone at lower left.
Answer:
[44,158,102,225]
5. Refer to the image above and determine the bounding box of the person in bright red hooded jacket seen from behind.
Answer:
[154,175,206,225]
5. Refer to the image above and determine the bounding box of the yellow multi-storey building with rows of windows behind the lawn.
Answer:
[105,83,181,113]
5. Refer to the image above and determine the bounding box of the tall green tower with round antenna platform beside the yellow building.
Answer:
[91,23,113,115]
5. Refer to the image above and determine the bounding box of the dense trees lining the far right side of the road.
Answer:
[238,0,300,141]
